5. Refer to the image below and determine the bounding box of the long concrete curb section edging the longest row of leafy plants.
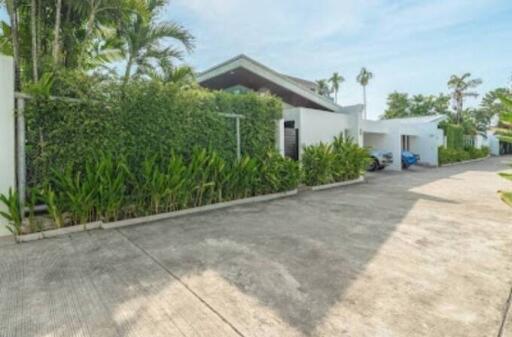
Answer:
[101,189,298,229]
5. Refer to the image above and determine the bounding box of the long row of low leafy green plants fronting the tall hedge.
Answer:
[15,148,301,227]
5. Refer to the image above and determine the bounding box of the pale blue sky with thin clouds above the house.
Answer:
[0,0,512,118]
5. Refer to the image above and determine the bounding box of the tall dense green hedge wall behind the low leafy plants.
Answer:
[26,82,282,186]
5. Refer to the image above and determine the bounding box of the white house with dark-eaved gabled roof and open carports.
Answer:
[198,55,446,171]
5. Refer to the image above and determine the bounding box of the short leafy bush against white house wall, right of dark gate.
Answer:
[302,136,370,186]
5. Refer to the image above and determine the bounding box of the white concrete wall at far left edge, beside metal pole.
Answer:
[0,55,16,236]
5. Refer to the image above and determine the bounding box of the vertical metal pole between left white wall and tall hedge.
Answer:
[16,98,27,219]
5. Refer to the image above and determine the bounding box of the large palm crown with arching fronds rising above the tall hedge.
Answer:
[120,0,194,83]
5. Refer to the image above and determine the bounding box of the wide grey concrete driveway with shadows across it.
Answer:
[0,157,512,337]
